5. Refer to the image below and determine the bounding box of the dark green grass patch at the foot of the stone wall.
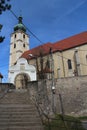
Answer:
[45,114,85,130]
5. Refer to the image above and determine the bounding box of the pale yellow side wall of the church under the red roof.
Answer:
[29,45,87,78]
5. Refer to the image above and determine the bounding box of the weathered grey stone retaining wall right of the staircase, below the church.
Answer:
[28,76,87,116]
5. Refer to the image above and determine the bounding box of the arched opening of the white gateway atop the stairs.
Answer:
[14,73,30,89]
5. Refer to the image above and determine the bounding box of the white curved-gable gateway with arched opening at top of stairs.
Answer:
[9,58,36,89]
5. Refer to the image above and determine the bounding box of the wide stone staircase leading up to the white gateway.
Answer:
[0,90,43,130]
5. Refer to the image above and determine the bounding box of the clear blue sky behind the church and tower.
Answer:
[0,0,87,82]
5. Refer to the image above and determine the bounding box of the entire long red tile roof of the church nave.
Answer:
[21,31,87,59]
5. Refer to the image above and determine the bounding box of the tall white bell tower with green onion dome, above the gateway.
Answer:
[9,17,29,68]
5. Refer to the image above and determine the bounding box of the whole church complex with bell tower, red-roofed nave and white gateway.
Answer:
[9,17,87,89]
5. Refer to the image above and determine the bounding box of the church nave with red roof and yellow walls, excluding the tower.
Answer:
[22,31,87,79]
